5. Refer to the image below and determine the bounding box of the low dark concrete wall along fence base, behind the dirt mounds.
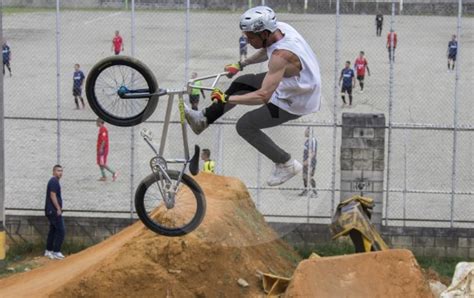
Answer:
[6,216,474,259]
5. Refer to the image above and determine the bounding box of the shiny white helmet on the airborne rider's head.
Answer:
[240,6,277,33]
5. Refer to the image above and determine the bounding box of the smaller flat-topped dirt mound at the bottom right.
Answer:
[285,249,433,298]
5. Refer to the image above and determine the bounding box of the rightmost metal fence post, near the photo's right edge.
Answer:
[450,0,462,228]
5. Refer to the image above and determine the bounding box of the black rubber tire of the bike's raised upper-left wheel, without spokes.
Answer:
[86,56,158,126]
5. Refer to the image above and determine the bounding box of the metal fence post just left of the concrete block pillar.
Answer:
[329,0,341,216]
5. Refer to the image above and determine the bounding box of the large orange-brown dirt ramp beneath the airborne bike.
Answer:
[0,174,299,297]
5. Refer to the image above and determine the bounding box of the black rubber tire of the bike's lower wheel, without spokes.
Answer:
[135,170,206,237]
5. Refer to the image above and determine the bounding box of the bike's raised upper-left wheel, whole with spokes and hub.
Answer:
[86,56,158,126]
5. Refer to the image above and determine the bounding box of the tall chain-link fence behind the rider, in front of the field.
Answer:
[3,0,474,227]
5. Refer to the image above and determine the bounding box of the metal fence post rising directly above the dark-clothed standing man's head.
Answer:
[56,0,61,164]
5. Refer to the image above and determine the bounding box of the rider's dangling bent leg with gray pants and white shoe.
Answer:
[236,103,302,186]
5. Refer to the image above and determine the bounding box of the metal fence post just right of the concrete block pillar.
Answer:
[382,0,395,225]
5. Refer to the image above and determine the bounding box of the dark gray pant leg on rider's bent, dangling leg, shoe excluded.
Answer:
[236,103,300,163]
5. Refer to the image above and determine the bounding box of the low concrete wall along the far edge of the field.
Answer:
[3,0,474,15]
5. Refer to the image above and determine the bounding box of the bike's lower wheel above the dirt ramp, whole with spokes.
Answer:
[135,170,206,237]
